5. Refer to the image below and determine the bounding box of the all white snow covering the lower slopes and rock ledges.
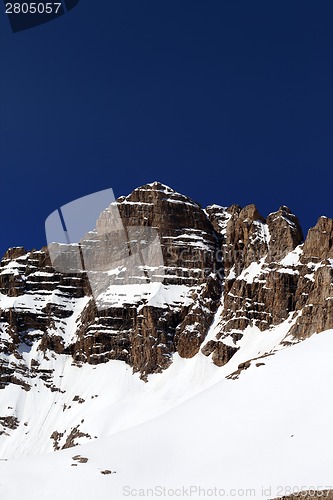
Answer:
[0,213,333,500]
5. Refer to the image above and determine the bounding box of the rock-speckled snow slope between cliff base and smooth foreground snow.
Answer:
[0,311,298,458]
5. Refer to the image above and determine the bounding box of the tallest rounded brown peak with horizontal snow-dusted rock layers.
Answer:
[64,183,222,376]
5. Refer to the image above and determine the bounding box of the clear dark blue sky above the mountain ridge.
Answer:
[0,0,333,253]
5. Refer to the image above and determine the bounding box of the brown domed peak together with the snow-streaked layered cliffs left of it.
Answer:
[0,183,222,386]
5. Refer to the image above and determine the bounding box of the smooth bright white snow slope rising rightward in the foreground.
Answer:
[0,330,333,500]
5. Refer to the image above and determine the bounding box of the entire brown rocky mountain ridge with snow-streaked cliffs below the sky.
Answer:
[0,182,333,458]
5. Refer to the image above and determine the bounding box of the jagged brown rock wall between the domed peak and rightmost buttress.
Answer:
[217,205,303,334]
